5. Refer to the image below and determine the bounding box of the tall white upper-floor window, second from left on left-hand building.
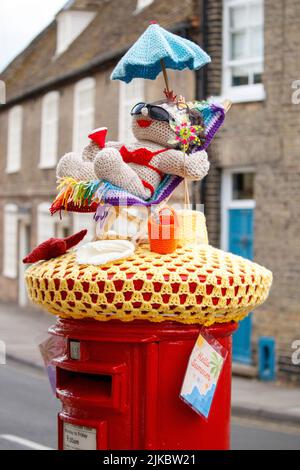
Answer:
[40,91,59,169]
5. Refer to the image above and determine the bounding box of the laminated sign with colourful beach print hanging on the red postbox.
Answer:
[180,333,227,418]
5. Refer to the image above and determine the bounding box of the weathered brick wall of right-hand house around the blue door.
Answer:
[206,0,300,378]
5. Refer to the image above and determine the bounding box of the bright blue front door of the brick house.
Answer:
[228,209,254,364]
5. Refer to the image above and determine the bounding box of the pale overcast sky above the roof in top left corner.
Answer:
[0,0,67,71]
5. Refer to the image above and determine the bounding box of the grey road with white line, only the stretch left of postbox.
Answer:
[0,359,61,451]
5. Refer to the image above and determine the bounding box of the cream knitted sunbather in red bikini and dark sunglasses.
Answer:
[57,102,209,200]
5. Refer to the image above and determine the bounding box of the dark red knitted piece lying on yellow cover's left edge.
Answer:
[23,230,87,264]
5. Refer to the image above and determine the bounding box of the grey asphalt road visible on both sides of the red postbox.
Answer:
[0,362,300,450]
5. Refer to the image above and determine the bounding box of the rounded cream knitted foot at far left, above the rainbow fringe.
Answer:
[56,152,96,181]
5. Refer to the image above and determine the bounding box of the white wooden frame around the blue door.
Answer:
[221,166,256,251]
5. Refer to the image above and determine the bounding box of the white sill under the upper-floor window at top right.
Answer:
[213,84,266,103]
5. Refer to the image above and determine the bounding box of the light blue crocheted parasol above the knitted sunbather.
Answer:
[111,24,211,88]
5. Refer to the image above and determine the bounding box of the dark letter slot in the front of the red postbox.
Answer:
[58,370,112,399]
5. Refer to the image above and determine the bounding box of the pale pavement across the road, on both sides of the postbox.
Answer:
[0,303,300,426]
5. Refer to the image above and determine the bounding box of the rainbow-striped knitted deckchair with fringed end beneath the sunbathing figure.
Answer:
[50,101,226,214]
